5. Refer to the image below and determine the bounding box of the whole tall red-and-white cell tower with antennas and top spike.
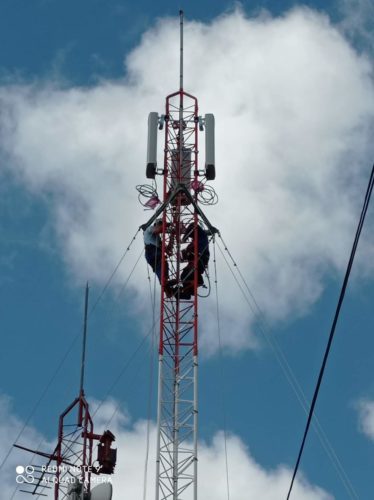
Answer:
[141,11,217,500]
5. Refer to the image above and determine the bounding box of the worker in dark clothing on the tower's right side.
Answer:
[180,223,210,299]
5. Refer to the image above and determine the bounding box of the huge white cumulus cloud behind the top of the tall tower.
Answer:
[0,8,374,351]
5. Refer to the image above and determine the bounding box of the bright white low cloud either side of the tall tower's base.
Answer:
[106,421,333,500]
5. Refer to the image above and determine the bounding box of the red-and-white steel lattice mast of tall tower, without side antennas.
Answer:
[156,88,199,500]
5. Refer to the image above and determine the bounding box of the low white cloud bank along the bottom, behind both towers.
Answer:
[0,399,333,500]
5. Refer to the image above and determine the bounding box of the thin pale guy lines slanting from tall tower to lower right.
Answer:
[217,235,358,500]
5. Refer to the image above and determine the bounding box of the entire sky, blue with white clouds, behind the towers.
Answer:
[0,0,374,500]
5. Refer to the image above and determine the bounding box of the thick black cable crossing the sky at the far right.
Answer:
[287,165,374,500]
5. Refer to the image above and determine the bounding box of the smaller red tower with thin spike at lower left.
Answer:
[14,285,117,500]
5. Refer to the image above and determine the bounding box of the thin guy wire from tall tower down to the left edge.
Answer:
[0,229,140,471]
